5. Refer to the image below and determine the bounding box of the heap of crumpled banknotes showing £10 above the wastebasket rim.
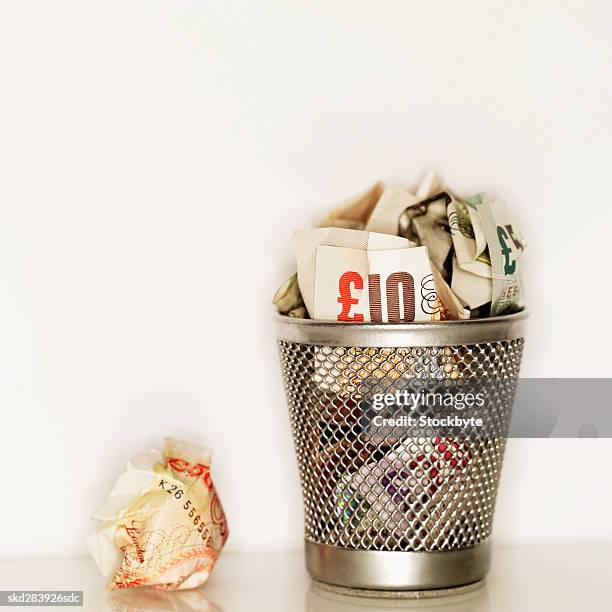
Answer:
[273,172,525,323]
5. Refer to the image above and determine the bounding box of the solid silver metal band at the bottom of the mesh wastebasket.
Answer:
[305,541,491,591]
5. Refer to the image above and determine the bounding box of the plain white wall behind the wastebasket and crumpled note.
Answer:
[0,0,612,557]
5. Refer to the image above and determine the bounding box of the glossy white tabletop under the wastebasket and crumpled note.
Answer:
[0,544,612,612]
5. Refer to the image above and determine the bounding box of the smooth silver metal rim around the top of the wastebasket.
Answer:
[274,308,529,347]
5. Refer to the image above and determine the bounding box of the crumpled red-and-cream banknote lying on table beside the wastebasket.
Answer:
[87,438,228,590]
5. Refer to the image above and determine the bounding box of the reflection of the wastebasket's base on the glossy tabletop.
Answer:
[306,583,492,612]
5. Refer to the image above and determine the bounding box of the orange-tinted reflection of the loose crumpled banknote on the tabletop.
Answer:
[105,587,223,612]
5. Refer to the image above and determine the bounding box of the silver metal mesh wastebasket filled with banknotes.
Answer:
[276,312,526,590]
